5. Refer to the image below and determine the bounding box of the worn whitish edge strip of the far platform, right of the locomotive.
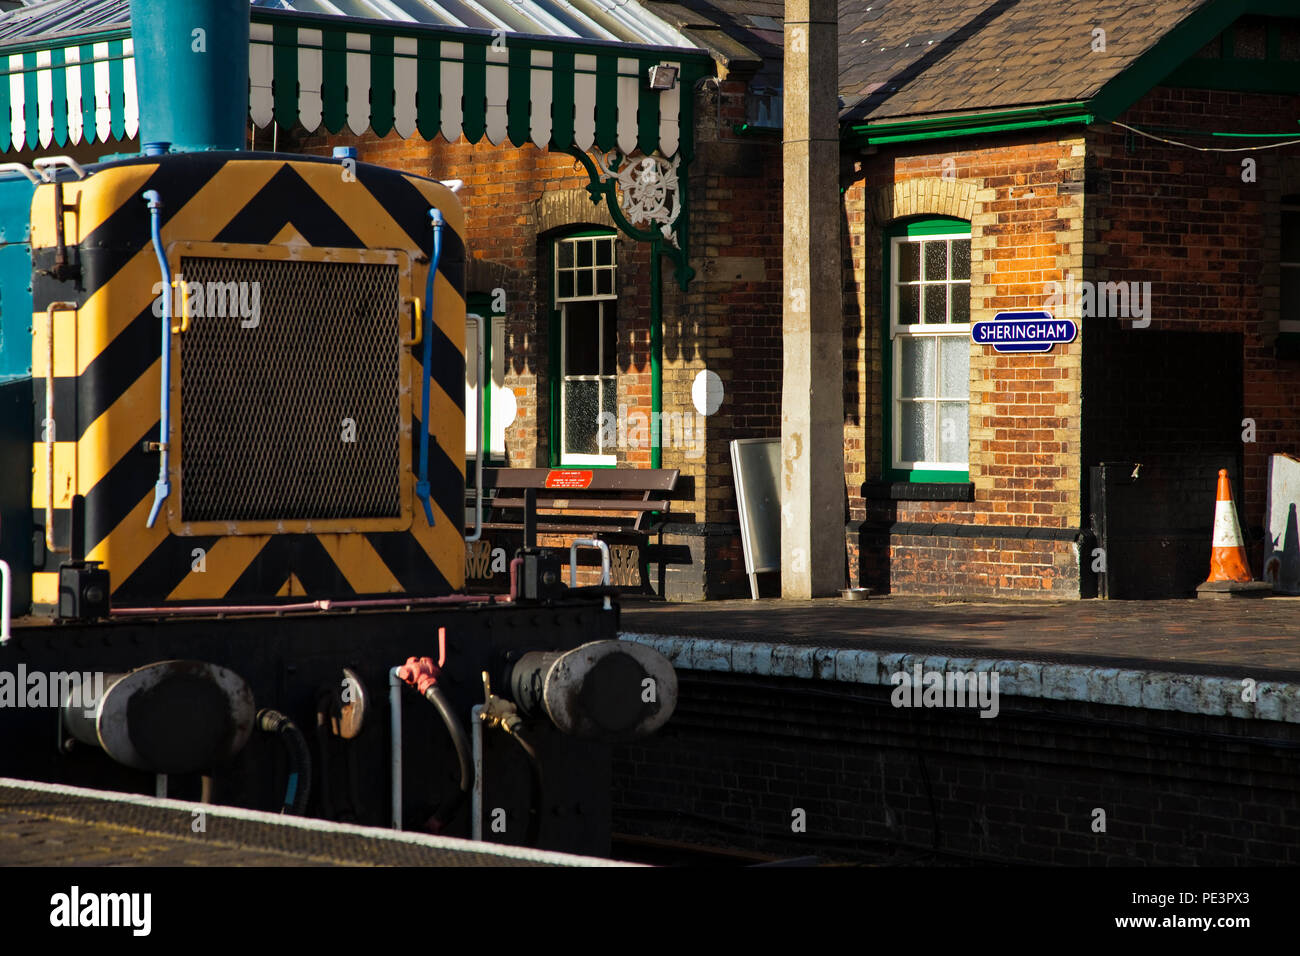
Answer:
[619,631,1300,723]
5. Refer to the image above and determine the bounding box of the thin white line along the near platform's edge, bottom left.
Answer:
[0,777,641,866]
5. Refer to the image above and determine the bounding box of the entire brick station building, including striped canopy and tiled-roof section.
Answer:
[0,0,1300,600]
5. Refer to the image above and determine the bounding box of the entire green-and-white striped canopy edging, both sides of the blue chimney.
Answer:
[0,10,712,159]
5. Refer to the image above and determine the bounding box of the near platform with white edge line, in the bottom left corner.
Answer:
[0,778,633,866]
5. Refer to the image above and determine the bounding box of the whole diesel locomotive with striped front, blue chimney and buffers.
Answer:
[0,0,675,853]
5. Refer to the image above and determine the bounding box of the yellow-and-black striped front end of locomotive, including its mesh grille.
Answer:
[4,152,464,610]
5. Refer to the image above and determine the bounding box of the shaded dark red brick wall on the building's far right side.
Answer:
[1088,87,1300,556]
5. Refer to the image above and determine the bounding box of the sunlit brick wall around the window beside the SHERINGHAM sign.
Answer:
[844,131,1083,597]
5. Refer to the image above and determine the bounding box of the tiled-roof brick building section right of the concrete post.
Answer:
[840,0,1300,597]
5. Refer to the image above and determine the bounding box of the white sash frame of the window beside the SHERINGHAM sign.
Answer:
[889,228,971,472]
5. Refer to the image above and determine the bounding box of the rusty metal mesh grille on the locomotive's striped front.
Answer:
[181,256,402,522]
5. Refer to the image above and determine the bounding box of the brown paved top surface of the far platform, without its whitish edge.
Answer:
[620,597,1300,683]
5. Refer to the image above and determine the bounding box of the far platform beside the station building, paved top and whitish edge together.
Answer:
[620,597,1300,724]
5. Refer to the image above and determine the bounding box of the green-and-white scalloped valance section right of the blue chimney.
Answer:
[250,18,711,156]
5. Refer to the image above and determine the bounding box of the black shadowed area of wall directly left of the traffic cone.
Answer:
[1082,327,1242,600]
